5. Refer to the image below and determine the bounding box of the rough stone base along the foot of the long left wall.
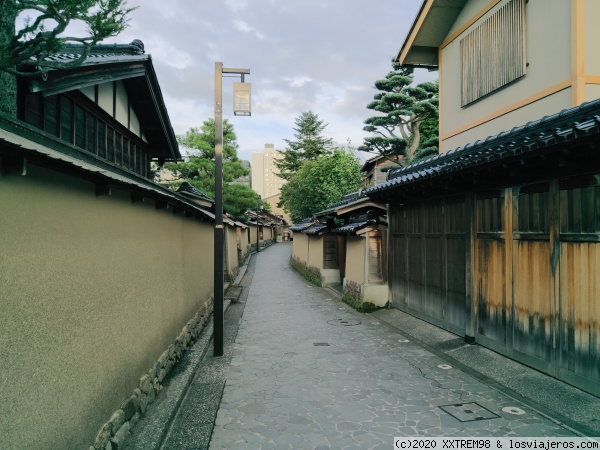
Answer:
[89,300,213,450]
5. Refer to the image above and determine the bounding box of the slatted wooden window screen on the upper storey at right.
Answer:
[460,0,527,106]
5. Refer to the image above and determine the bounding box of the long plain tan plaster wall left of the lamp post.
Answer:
[0,164,213,450]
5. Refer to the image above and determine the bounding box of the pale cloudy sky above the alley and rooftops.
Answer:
[105,0,437,160]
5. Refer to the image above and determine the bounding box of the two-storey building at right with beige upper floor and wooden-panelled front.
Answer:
[366,0,600,395]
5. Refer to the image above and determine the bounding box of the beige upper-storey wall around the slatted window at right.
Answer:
[440,0,572,152]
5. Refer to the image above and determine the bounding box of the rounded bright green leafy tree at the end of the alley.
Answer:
[280,148,362,222]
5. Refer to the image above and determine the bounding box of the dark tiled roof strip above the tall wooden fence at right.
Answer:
[365,100,600,196]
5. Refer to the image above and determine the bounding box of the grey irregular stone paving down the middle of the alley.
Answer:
[209,244,573,449]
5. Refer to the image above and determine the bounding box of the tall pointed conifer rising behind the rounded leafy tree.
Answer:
[275,111,333,180]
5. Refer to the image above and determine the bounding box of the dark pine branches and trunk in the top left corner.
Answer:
[0,0,135,116]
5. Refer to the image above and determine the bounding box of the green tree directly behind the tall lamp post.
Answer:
[165,118,260,220]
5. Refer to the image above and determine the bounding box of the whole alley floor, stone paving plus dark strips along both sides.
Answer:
[125,244,600,450]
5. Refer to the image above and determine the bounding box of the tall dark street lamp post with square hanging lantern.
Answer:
[213,62,250,356]
